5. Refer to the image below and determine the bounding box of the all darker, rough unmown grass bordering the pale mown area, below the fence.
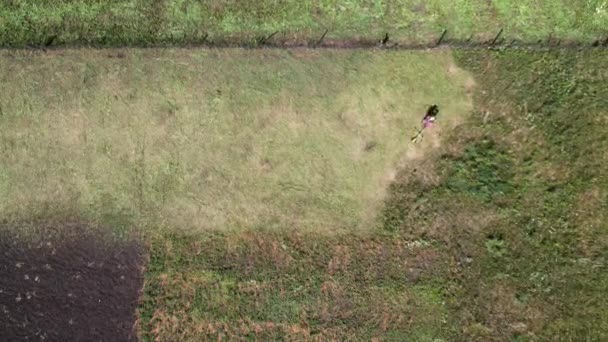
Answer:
[140,50,608,341]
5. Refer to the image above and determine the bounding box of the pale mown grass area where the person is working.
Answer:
[0,49,472,231]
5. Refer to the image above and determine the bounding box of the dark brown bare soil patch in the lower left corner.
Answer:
[0,225,143,342]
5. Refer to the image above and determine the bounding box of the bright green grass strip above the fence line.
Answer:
[0,0,608,46]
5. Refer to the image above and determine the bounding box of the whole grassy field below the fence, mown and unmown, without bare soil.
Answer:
[0,49,608,341]
